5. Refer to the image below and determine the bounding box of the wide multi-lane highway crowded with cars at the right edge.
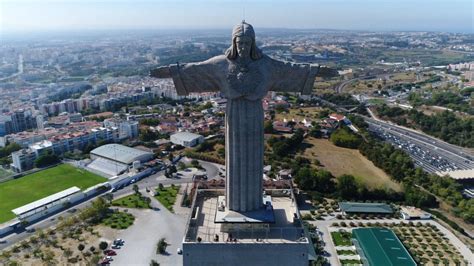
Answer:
[365,117,474,173]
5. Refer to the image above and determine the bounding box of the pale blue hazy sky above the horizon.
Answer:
[0,0,474,33]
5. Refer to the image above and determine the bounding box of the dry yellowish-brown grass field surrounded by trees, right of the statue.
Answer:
[303,138,401,191]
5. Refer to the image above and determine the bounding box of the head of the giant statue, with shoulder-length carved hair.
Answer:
[225,21,262,60]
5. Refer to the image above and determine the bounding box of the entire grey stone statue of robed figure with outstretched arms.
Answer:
[150,21,337,213]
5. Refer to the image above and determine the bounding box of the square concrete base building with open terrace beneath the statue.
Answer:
[183,189,314,266]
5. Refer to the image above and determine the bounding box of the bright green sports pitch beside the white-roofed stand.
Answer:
[0,164,107,223]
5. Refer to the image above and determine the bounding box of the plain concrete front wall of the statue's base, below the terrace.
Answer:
[183,242,308,266]
